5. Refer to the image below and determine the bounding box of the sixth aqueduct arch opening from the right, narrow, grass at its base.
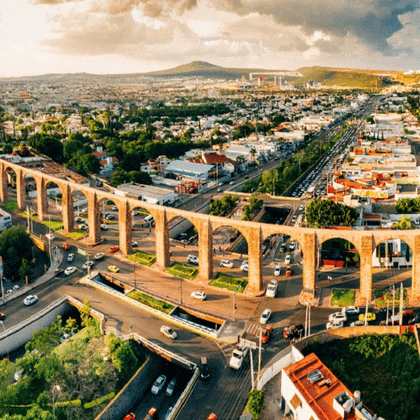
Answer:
[131,206,156,267]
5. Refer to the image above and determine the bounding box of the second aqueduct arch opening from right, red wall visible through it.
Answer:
[315,238,360,307]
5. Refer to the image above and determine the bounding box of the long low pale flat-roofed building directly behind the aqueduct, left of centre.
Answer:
[114,184,178,206]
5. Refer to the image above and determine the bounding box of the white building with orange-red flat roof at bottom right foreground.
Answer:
[281,353,383,420]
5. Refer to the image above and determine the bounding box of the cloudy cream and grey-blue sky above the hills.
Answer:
[0,0,420,77]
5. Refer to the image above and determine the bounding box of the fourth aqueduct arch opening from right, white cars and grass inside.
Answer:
[210,225,249,293]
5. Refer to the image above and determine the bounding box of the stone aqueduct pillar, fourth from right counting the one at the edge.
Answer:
[246,226,263,293]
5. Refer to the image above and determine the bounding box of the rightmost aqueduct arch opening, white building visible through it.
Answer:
[372,239,413,309]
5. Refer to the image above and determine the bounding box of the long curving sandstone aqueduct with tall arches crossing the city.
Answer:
[0,160,420,298]
